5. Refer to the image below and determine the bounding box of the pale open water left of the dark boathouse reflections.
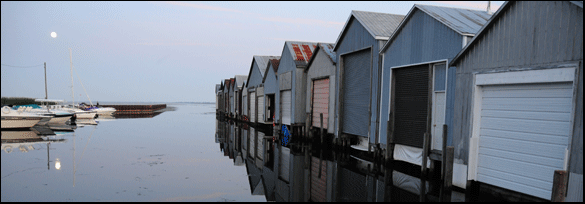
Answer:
[0,104,266,202]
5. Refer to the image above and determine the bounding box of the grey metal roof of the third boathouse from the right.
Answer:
[333,10,404,50]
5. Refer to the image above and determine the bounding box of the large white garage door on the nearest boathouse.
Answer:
[477,83,573,199]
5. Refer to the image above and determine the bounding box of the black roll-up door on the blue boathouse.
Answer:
[394,64,429,148]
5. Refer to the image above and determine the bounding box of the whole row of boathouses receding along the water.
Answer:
[216,1,583,201]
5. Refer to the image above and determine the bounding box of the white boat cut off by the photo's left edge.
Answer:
[1,106,50,128]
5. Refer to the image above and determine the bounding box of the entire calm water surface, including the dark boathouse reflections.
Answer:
[0,103,544,202]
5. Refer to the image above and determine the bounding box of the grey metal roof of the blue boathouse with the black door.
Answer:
[414,4,492,35]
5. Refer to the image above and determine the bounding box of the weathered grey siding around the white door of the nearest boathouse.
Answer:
[453,1,583,166]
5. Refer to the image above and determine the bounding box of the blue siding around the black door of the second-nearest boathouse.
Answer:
[380,7,462,144]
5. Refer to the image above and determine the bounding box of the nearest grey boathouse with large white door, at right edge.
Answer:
[450,1,583,201]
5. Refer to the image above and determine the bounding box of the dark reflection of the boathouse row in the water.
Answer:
[215,120,464,202]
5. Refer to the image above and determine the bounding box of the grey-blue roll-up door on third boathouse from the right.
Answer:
[342,49,371,137]
